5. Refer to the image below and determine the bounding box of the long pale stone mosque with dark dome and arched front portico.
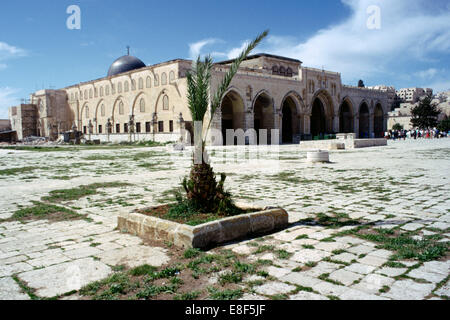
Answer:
[9,54,390,143]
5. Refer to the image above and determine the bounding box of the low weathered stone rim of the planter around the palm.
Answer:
[118,205,288,249]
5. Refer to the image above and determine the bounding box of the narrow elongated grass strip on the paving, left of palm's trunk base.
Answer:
[42,182,131,202]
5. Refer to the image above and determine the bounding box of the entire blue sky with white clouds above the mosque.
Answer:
[0,0,450,118]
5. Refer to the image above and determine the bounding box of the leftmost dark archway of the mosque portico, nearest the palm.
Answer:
[221,91,245,145]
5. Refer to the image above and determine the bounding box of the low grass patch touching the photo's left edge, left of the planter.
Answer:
[0,201,92,222]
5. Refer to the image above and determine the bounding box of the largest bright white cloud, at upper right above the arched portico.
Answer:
[265,0,450,79]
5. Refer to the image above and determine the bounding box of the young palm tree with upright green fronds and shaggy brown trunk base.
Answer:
[183,30,269,213]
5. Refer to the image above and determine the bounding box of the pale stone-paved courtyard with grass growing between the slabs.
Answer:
[0,139,450,300]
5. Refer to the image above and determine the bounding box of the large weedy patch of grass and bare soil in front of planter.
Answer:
[79,247,270,300]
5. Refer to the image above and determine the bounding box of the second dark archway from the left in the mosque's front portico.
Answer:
[253,93,274,144]
